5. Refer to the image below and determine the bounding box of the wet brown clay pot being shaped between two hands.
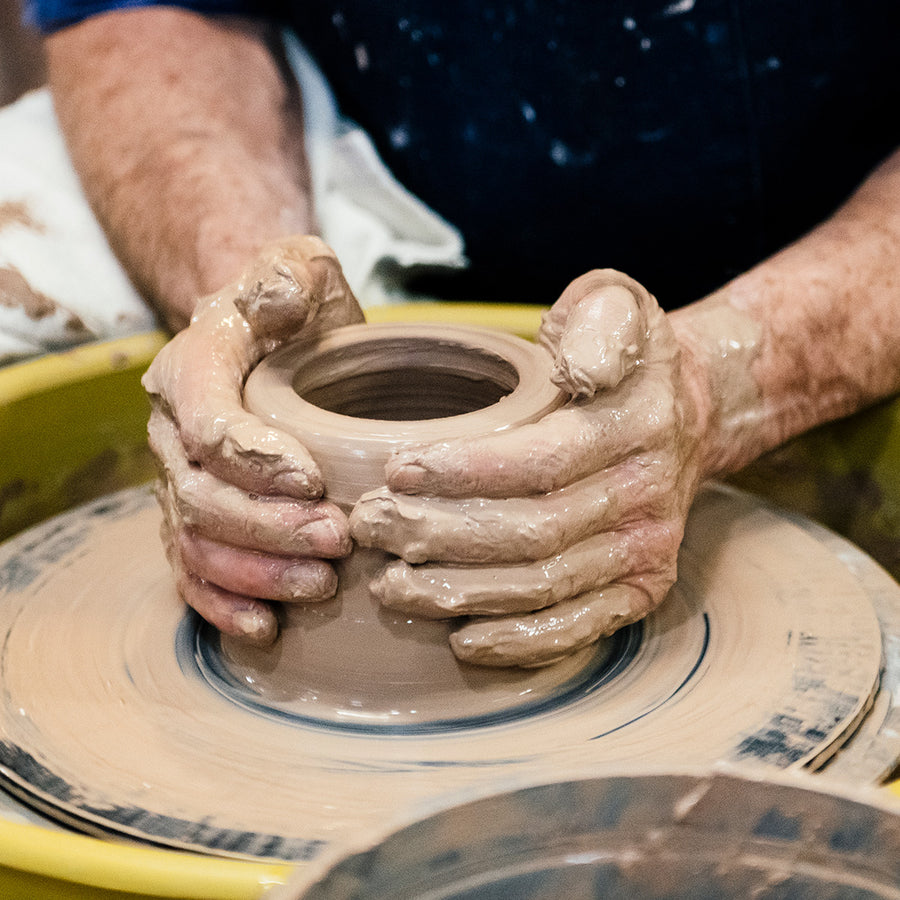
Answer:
[229,324,584,722]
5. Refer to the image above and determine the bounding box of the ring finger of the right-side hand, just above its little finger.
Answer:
[371,522,681,619]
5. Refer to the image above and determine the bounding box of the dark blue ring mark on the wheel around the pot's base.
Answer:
[181,613,648,735]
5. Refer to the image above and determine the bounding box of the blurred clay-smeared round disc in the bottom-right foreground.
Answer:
[284,770,900,900]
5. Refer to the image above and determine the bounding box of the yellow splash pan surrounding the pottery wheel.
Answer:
[0,303,900,900]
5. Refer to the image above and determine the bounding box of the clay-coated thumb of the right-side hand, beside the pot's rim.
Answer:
[540,269,655,397]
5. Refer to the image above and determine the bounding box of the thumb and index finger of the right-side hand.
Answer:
[385,270,681,498]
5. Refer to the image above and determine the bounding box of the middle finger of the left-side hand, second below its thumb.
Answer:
[150,416,351,558]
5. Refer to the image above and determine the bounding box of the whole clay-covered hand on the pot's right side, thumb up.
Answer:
[350,270,702,666]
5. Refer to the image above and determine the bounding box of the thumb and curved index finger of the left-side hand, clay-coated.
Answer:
[143,236,363,499]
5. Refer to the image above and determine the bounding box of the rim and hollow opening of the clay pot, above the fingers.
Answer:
[244,323,564,504]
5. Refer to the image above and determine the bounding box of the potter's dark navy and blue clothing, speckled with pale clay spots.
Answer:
[24,0,900,308]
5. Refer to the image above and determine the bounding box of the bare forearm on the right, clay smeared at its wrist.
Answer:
[670,153,900,475]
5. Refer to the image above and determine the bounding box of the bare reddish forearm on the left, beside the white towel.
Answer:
[47,7,314,328]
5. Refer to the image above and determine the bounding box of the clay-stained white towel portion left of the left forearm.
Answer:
[0,90,155,363]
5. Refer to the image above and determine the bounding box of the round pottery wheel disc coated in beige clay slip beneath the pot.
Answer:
[0,487,900,859]
